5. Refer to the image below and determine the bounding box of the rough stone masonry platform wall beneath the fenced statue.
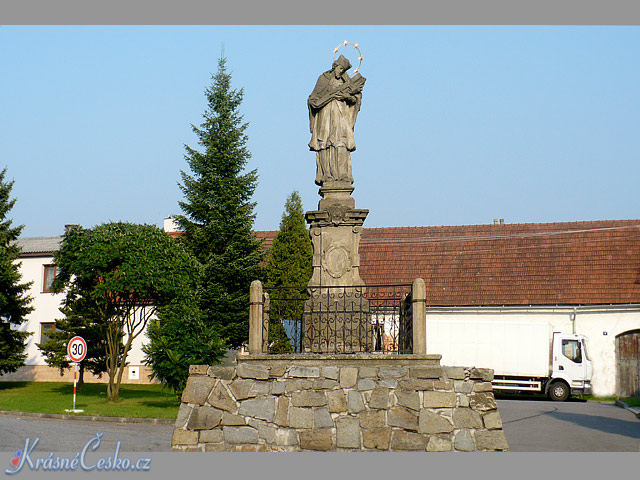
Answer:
[172,354,508,452]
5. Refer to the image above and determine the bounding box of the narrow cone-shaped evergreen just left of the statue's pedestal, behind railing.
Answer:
[266,190,313,352]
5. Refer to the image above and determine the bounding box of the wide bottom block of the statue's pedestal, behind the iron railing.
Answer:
[302,287,374,353]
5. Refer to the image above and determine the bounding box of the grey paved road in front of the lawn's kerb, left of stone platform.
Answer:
[0,415,173,452]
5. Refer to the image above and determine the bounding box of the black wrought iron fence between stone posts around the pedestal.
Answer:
[262,284,412,354]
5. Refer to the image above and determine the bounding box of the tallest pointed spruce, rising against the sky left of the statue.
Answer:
[175,57,263,347]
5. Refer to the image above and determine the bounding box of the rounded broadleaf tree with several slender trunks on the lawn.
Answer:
[52,223,199,402]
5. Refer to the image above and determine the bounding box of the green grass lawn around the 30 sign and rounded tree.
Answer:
[0,382,180,418]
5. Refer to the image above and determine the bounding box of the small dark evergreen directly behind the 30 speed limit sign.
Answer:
[37,297,117,391]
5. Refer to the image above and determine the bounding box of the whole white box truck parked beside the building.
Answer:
[427,315,593,401]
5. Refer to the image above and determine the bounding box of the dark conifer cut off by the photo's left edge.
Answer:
[0,168,33,375]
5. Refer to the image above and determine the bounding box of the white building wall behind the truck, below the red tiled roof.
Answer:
[427,305,640,396]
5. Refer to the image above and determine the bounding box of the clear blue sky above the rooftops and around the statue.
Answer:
[0,26,640,236]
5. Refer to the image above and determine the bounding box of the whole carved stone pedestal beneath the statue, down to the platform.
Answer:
[302,182,373,353]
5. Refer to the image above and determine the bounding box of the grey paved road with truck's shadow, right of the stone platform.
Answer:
[497,399,640,452]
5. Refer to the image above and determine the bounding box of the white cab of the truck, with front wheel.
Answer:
[545,332,593,401]
